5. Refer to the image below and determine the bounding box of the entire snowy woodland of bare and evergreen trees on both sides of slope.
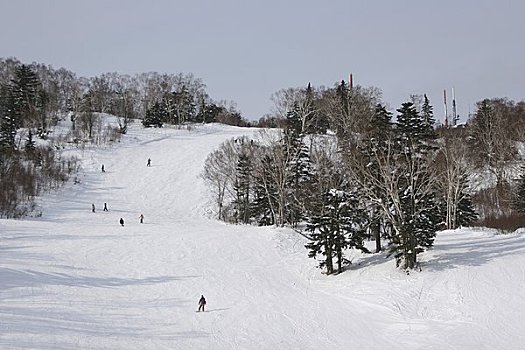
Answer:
[0,58,525,273]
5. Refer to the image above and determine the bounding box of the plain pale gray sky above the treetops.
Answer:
[0,0,525,120]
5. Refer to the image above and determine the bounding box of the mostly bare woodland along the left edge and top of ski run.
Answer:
[0,58,249,218]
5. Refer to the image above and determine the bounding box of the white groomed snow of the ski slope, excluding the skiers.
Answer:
[0,124,525,350]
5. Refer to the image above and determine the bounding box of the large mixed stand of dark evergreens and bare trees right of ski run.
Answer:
[203,81,525,274]
